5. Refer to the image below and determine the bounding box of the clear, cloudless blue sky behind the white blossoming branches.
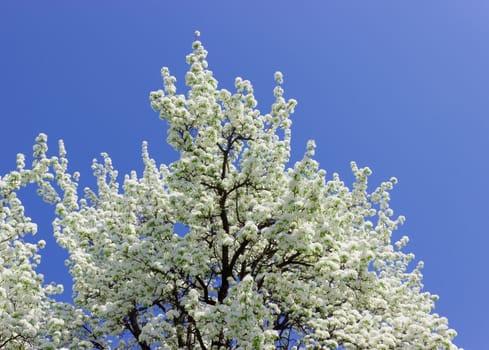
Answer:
[0,0,489,349]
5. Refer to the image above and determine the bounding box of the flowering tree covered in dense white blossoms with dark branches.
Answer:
[0,36,456,349]
